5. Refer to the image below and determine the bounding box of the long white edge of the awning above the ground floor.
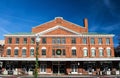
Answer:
[0,57,120,61]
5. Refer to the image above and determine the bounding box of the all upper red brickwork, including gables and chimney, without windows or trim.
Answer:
[3,18,114,58]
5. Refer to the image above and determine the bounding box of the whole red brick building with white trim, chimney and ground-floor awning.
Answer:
[0,17,120,75]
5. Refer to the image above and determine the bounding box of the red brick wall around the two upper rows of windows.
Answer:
[4,37,114,58]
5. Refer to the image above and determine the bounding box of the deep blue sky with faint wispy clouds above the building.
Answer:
[0,0,120,46]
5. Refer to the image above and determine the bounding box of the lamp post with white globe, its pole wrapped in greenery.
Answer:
[34,35,40,78]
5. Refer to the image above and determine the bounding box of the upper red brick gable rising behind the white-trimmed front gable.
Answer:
[32,17,88,33]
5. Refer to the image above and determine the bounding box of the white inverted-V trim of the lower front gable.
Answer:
[36,25,80,35]
